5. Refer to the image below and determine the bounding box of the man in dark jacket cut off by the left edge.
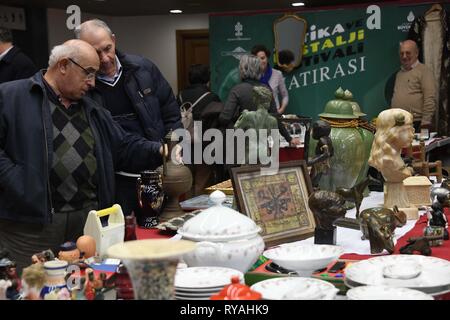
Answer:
[0,27,37,83]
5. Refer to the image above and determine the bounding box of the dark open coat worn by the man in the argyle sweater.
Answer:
[0,72,161,223]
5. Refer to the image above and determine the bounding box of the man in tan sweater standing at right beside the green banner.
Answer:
[391,40,436,132]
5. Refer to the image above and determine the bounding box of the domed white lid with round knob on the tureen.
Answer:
[178,190,261,241]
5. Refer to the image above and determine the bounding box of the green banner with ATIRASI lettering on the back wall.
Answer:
[209,4,449,119]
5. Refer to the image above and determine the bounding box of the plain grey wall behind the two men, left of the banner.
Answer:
[47,9,209,94]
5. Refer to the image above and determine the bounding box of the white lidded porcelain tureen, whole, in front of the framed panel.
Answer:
[178,191,264,272]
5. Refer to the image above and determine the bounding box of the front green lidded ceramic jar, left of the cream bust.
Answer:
[319,88,370,191]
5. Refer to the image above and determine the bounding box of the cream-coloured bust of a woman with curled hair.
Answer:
[369,109,414,182]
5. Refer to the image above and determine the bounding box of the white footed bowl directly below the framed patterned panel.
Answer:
[263,243,344,277]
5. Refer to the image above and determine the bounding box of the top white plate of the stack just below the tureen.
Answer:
[175,267,244,289]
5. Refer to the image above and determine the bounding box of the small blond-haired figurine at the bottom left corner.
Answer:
[22,263,46,300]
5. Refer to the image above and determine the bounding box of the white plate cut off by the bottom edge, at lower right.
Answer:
[347,286,434,300]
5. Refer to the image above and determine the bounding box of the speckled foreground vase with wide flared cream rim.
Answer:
[108,239,195,300]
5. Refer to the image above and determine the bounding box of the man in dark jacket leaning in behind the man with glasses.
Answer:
[75,19,182,222]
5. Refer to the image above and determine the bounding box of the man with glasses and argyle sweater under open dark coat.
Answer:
[0,40,162,269]
